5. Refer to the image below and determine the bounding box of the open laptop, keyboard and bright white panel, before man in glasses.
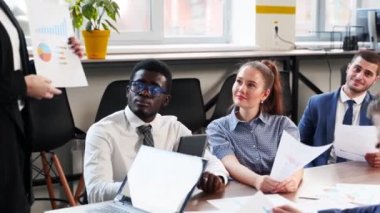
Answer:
[48,146,207,213]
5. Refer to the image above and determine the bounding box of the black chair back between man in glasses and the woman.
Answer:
[160,78,206,132]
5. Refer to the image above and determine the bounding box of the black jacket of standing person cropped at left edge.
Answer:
[0,0,31,212]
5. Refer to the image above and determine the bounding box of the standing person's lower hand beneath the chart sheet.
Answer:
[25,75,62,99]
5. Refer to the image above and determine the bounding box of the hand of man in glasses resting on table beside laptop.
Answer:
[197,172,225,193]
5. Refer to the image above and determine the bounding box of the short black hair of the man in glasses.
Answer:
[130,59,172,94]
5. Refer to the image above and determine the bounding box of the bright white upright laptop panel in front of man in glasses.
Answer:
[128,146,205,212]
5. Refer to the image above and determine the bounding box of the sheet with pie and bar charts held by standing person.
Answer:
[26,0,87,87]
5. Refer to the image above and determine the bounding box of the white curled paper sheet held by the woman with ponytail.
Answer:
[270,131,332,181]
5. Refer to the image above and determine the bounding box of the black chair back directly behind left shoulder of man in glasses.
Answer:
[95,80,129,122]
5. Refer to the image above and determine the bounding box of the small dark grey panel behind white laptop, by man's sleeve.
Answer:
[177,134,207,157]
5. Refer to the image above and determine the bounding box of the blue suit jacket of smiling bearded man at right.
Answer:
[298,89,373,166]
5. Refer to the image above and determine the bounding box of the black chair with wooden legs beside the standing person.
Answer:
[26,89,84,209]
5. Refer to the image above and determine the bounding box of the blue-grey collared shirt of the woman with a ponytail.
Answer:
[206,108,300,175]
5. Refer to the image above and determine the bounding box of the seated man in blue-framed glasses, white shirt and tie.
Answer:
[84,59,228,203]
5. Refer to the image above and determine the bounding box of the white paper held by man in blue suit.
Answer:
[334,125,378,161]
